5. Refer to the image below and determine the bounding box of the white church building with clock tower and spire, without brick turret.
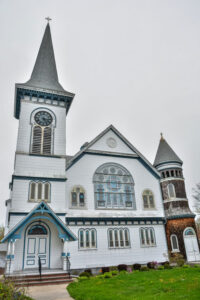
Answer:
[2,24,192,273]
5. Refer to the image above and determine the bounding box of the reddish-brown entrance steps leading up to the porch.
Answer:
[6,272,73,287]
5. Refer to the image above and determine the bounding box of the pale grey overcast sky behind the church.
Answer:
[0,0,200,223]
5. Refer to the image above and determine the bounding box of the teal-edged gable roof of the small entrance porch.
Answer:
[1,201,77,243]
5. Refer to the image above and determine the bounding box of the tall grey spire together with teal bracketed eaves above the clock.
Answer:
[15,22,75,118]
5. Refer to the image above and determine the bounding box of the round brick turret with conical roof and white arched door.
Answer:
[154,134,199,261]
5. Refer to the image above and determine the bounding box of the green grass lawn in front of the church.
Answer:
[67,267,200,300]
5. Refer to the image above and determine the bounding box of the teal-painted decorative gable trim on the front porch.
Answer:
[2,201,77,243]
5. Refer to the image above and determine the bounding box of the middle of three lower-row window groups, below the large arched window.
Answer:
[108,228,130,248]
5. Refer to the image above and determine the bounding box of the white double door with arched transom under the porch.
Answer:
[24,224,49,269]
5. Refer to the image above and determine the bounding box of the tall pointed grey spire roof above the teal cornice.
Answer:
[23,23,73,96]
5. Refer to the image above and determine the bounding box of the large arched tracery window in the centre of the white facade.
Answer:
[93,163,136,209]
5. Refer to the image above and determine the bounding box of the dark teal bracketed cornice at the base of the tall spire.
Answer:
[14,87,74,119]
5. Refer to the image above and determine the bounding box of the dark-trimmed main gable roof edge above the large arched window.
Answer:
[66,124,160,178]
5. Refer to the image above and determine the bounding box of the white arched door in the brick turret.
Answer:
[184,228,200,261]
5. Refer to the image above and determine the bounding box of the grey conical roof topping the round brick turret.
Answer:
[154,135,183,167]
